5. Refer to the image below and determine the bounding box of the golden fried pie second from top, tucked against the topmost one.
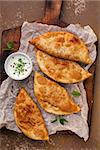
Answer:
[36,50,92,83]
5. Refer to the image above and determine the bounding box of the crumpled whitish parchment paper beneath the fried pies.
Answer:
[0,22,97,141]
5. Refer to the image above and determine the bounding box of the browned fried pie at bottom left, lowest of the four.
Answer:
[14,88,49,140]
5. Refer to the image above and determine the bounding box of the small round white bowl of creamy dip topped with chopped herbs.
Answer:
[4,52,32,80]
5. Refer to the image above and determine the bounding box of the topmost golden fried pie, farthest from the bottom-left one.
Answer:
[29,31,92,64]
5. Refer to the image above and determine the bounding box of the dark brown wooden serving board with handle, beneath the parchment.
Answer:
[0,0,96,128]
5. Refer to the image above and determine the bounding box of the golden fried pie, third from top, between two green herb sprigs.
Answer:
[34,72,80,115]
